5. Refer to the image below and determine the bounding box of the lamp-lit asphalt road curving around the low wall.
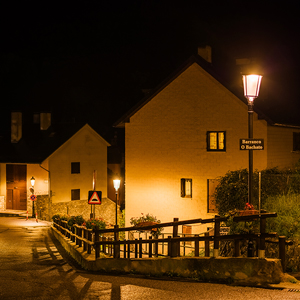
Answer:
[0,217,300,300]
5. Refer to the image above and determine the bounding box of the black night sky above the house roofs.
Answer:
[0,0,300,141]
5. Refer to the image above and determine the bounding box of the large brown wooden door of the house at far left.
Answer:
[6,164,27,210]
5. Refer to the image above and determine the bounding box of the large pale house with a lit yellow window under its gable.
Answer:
[115,52,300,233]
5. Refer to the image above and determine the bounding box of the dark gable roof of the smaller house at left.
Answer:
[0,123,110,164]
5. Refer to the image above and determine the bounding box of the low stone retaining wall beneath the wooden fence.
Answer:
[52,227,284,286]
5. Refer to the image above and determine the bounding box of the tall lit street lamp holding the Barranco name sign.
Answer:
[243,74,262,204]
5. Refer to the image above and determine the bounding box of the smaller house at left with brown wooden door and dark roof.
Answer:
[0,113,119,224]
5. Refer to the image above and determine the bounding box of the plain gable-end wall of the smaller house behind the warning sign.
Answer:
[46,125,109,203]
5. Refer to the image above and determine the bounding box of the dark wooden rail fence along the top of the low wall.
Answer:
[53,213,291,271]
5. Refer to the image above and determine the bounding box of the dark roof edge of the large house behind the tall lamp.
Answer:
[113,55,292,128]
